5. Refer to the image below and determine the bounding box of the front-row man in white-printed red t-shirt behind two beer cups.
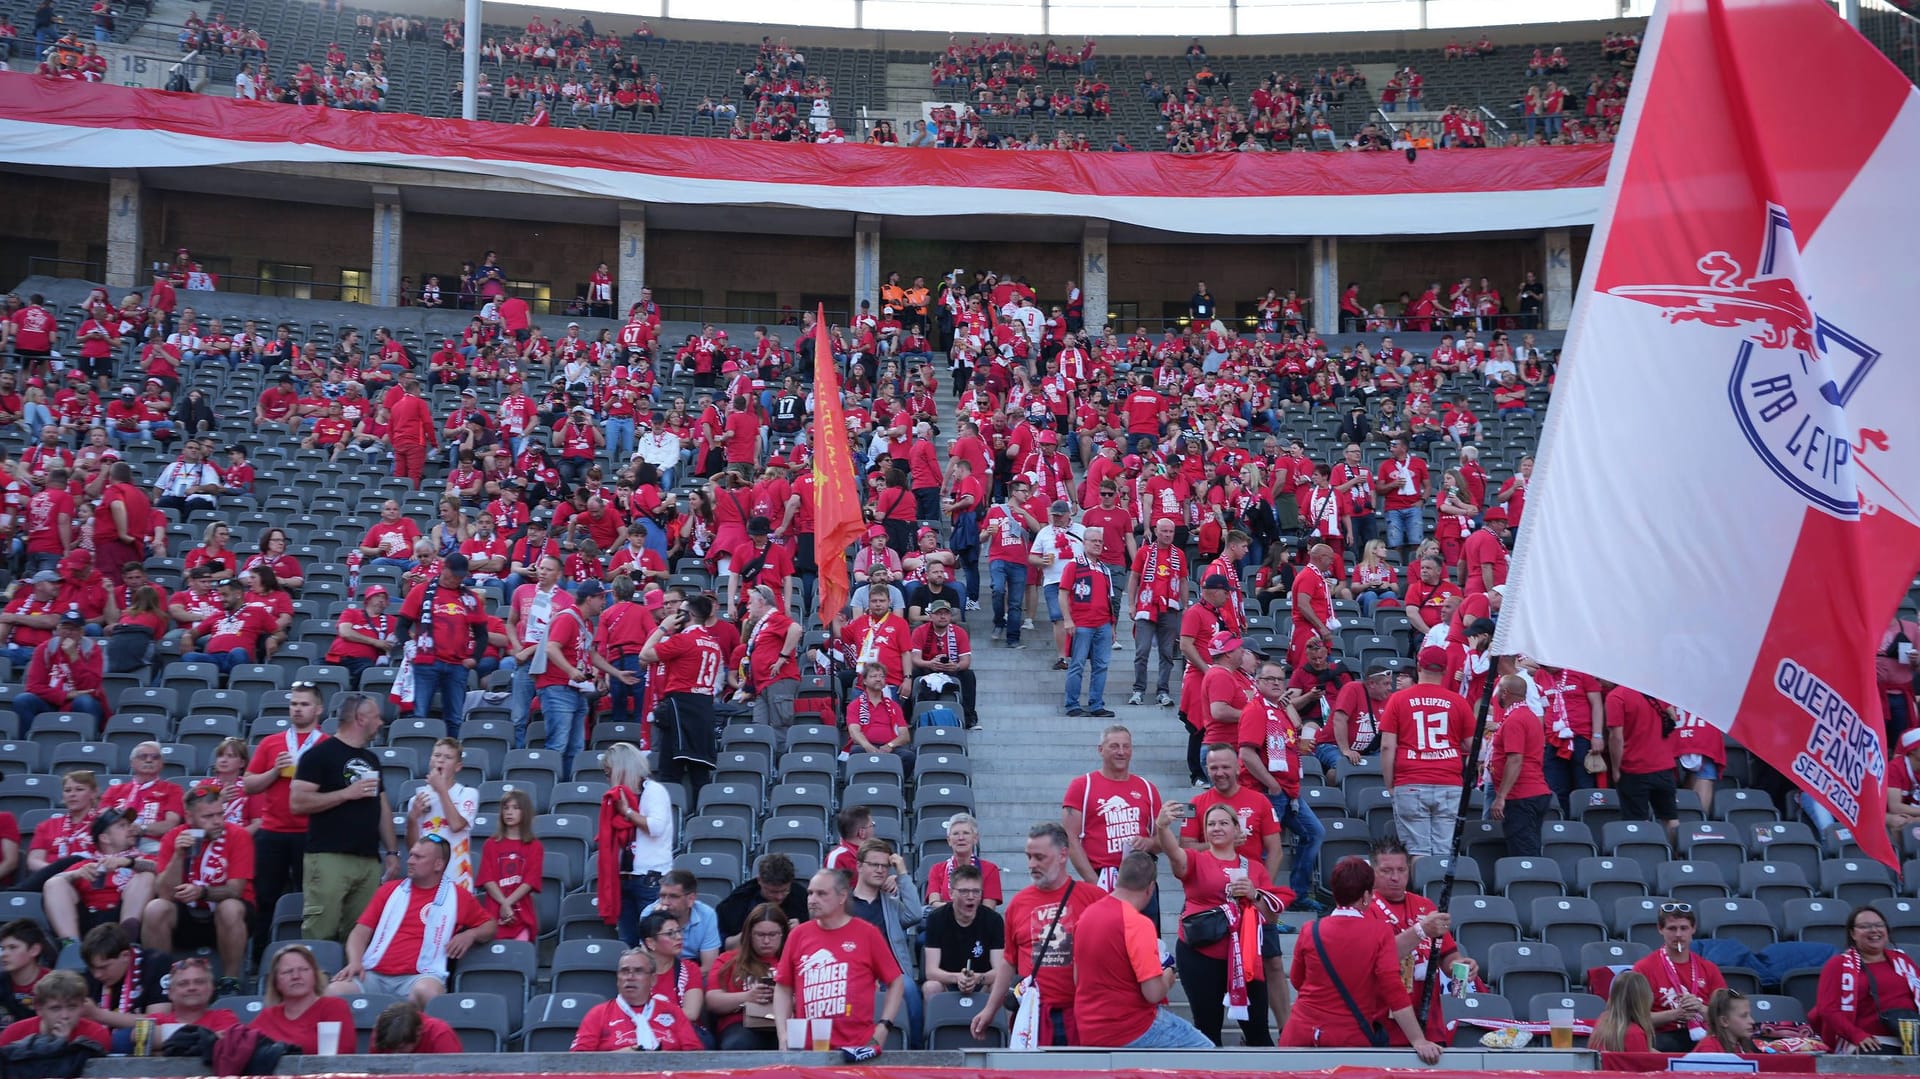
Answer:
[774,870,906,1062]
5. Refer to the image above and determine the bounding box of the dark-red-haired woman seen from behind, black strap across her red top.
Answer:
[1281,856,1440,1064]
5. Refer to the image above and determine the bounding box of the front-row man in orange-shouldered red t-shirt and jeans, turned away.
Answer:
[1073,851,1213,1048]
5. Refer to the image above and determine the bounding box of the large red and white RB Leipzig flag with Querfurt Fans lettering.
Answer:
[1494,0,1920,866]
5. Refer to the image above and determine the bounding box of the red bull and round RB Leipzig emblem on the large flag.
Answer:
[1607,204,1905,520]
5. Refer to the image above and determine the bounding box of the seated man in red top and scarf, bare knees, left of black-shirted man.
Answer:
[140,779,253,996]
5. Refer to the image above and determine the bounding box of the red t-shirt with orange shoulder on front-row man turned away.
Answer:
[1075,895,1162,1046]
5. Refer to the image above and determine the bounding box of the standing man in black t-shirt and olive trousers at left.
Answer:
[288,682,399,945]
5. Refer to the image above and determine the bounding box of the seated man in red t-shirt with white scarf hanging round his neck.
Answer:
[326,835,495,1006]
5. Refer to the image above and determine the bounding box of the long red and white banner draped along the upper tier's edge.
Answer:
[0,75,1611,236]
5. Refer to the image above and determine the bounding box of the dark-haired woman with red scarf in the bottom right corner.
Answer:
[1804,906,1920,1052]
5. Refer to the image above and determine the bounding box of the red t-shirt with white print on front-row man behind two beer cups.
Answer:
[774,918,900,1048]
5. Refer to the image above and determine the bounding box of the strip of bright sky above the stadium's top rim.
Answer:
[516,0,1653,36]
